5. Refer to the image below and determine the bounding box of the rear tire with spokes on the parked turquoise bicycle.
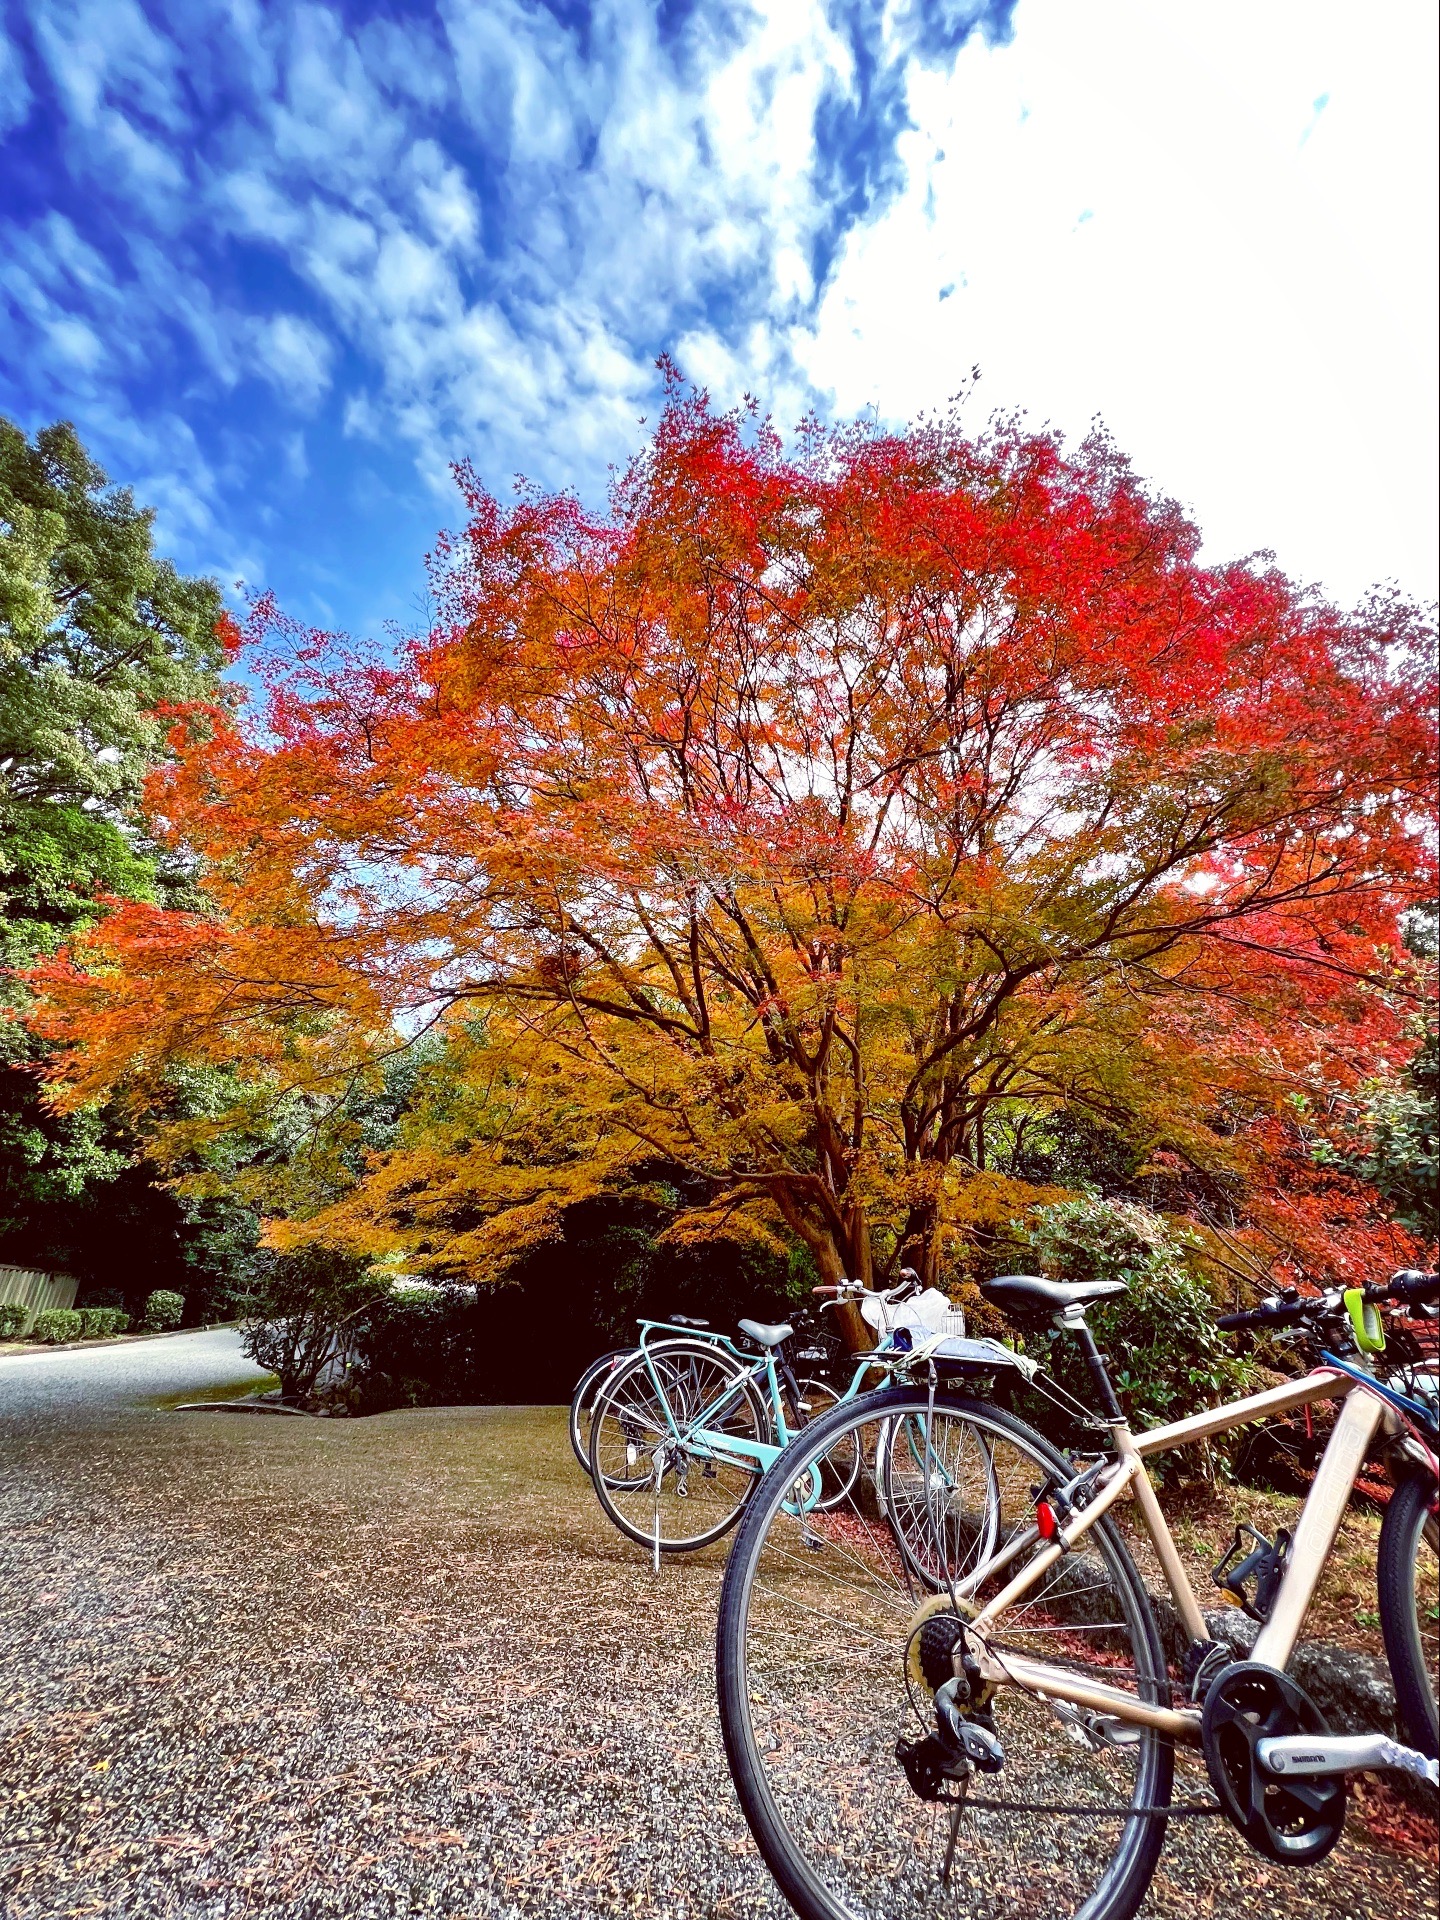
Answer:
[589,1340,774,1553]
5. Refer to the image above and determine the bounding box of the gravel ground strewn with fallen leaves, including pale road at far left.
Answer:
[0,1331,1436,1920]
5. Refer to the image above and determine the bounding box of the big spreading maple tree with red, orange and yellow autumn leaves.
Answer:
[28,382,1434,1328]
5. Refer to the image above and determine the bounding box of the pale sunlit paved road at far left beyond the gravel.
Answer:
[0,1327,261,1446]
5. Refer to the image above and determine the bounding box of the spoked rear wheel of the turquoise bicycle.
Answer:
[589,1340,772,1553]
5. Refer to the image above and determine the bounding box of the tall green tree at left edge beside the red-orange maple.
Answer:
[0,419,235,1298]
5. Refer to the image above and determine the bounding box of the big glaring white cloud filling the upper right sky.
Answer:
[793,0,1436,599]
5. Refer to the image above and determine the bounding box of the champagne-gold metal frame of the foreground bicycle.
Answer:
[954,1369,1396,1745]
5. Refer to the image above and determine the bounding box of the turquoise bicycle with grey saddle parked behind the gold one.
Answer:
[589,1271,1006,1569]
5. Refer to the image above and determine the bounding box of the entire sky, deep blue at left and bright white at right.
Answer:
[0,0,1436,630]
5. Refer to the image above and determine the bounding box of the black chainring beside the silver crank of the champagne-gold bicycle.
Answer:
[1200,1661,1346,1866]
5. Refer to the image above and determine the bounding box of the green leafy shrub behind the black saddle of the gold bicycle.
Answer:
[1027,1194,1252,1459]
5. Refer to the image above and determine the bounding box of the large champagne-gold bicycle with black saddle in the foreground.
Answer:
[716,1275,1440,1920]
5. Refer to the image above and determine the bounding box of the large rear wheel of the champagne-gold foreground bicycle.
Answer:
[716,1386,1175,1920]
